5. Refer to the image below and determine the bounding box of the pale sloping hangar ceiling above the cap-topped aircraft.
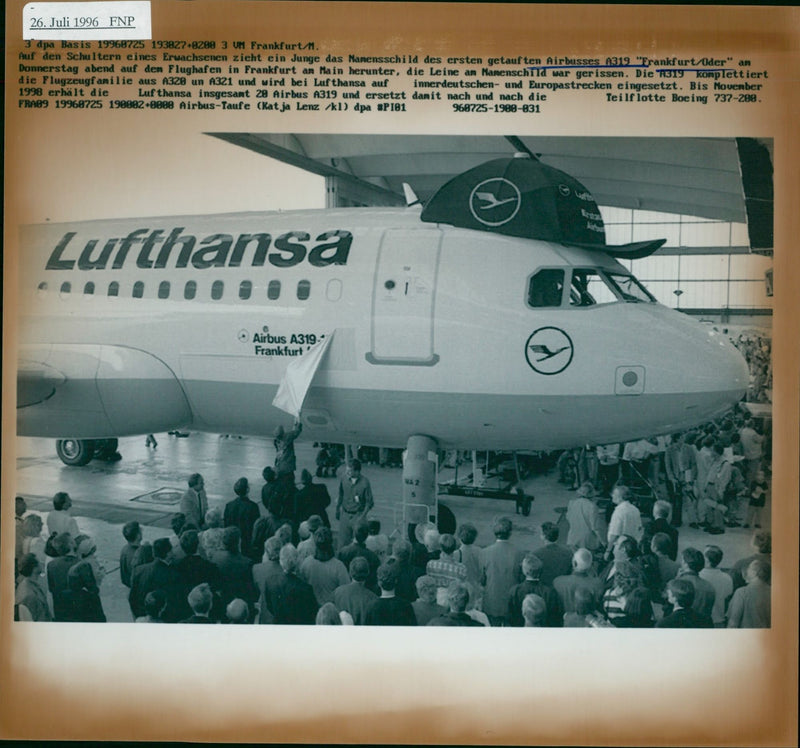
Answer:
[208,132,773,253]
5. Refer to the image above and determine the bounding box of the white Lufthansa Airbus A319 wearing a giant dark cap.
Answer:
[17,158,748,464]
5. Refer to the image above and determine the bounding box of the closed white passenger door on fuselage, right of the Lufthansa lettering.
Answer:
[367,229,442,366]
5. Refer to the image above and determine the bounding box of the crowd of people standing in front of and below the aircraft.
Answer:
[15,416,771,628]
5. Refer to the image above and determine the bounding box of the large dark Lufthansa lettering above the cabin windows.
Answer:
[45,227,353,270]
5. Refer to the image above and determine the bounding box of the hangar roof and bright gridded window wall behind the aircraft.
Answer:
[208,132,773,328]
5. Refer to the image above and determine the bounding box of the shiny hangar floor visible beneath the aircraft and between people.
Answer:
[16,432,771,622]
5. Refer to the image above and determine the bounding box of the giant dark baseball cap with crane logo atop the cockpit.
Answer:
[421,153,666,259]
